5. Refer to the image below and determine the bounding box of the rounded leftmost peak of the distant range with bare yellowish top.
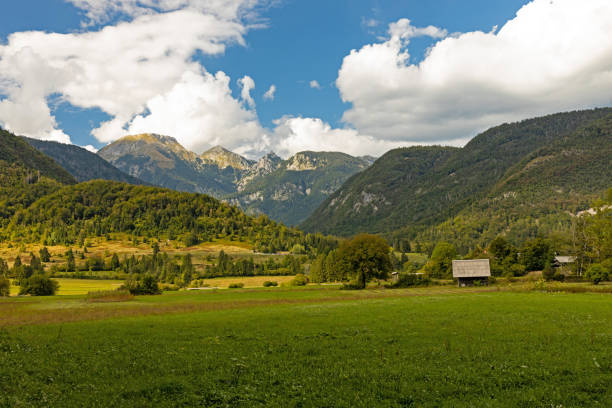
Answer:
[98,134,242,197]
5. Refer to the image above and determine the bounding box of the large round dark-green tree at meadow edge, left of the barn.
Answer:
[338,234,391,289]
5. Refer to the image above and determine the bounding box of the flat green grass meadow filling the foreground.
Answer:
[0,288,612,407]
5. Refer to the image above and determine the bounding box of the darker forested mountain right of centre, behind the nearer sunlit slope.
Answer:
[302,109,612,236]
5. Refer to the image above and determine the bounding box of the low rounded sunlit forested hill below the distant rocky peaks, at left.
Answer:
[2,180,310,251]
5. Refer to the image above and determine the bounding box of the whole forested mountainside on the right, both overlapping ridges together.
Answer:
[302,109,612,249]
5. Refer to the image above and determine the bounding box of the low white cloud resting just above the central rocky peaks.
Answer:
[273,116,398,157]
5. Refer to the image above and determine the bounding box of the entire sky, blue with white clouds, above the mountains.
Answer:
[0,0,612,158]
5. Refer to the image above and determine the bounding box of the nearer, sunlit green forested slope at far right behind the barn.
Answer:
[428,115,612,251]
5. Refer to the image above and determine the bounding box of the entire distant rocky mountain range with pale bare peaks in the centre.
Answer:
[98,134,371,225]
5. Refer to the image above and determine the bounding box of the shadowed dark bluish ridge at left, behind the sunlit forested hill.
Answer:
[23,137,145,185]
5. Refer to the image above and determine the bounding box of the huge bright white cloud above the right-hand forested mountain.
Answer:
[336,0,612,144]
